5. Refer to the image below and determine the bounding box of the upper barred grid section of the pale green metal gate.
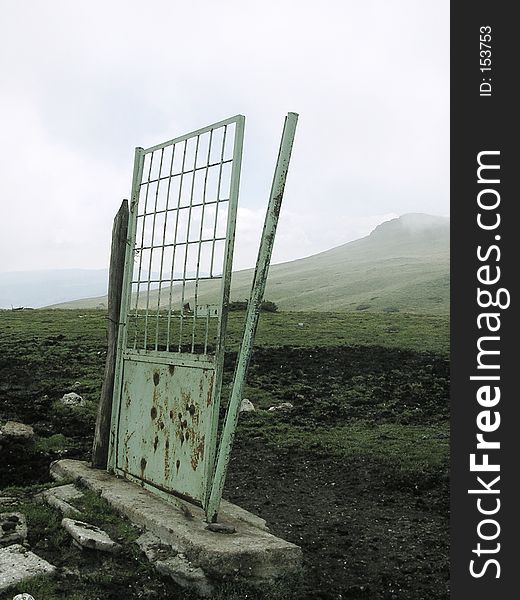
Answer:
[125,116,243,354]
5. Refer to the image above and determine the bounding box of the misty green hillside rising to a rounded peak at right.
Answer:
[39,213,450,314]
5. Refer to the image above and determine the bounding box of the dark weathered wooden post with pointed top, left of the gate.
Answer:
[92,200,129,469]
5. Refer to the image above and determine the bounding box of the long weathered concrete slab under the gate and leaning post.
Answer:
[51,460,301,583]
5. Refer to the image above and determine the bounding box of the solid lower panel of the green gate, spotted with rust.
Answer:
[116,357,215,504]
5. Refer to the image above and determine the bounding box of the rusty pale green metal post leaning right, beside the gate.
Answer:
[206,113,298,522]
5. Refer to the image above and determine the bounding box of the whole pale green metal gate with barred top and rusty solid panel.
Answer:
[109,115,245,506]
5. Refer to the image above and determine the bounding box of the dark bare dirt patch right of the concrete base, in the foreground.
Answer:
[226,440,449,600]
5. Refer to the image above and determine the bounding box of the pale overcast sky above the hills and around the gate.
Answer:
[0,0,449,271]
